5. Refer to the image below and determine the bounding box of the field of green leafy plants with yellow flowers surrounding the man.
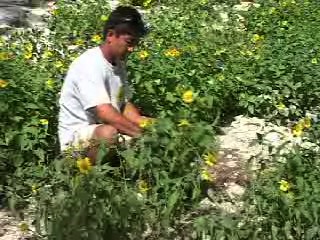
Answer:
[0,0,320,240]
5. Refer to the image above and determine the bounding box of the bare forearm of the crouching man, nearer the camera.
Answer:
[95,104,141,137]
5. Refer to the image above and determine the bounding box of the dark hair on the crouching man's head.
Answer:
[103,6,147,39]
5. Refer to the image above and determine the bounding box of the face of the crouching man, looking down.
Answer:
[108,32,138,60]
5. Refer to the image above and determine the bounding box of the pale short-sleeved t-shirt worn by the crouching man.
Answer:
[59,47,128,149]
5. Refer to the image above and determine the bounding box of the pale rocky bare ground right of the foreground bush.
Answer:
[202,115,290,213]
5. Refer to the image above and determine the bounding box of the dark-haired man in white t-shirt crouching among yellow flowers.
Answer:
[59,6,147,158]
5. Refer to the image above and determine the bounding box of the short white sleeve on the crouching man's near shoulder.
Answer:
[75,62,111,111]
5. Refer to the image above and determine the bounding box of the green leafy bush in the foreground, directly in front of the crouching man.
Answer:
[11,119,215,239]
